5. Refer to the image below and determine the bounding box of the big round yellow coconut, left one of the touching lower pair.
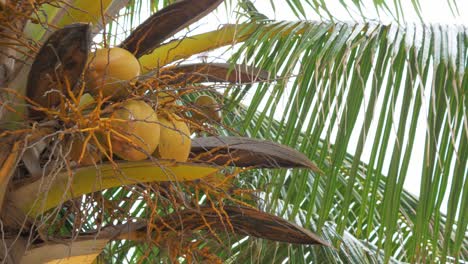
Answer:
[111,100,160,161]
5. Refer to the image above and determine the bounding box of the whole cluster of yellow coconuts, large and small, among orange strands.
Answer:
[66,48,221,165]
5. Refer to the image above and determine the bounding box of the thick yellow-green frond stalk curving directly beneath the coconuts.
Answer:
[8,161,220,217]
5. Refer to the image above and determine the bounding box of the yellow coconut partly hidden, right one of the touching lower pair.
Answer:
[154,114,192,162]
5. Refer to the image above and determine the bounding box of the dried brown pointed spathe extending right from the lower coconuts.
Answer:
[191,137,320,172]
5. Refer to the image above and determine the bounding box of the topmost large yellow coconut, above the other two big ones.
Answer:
[86,48,141,99]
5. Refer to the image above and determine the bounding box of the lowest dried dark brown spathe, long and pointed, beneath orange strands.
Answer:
[54,206,329,246]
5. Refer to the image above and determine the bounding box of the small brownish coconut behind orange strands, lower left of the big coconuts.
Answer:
[68,137,103,166]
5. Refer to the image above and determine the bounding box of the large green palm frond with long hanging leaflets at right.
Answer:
[227,22,468,261]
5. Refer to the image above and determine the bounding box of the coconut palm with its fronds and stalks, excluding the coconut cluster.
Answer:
[0,0,468,263]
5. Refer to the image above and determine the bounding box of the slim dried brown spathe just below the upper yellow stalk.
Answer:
[161,63,270,84]
